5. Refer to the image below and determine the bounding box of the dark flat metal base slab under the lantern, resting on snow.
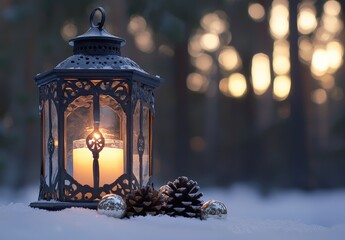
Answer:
[29,201,98,211]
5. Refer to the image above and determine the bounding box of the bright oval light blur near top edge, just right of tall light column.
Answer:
[297,5,317,34]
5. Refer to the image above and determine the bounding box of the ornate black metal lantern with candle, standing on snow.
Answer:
[30,7,160,210]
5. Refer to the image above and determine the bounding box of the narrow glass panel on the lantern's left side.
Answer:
[43,100,58,186]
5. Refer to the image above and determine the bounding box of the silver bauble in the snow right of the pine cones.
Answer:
[201,200,228,219]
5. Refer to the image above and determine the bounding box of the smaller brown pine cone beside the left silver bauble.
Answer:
[126,185,164,217]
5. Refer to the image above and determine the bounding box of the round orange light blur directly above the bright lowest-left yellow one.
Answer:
[218,47,241,71]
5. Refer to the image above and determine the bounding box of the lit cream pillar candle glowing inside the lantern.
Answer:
[73,139,124,187]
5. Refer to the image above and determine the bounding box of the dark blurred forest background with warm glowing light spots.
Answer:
[0,0,345,190]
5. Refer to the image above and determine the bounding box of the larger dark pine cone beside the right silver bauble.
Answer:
[163,177,202,218]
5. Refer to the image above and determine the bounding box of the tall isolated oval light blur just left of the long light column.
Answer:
[252,53,271,95]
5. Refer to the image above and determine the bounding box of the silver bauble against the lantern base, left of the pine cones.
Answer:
[97,194,127,218]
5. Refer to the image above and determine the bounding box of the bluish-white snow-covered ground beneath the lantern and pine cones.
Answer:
[0,186,345,240]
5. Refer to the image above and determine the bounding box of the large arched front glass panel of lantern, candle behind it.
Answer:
[65,95,126,187]
